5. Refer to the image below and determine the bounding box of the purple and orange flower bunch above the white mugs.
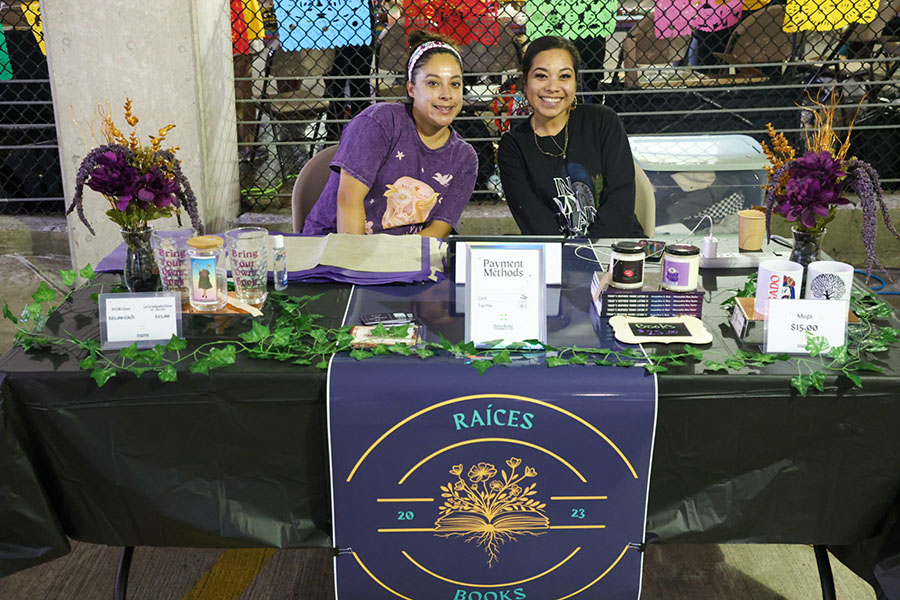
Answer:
[762,94,900,273]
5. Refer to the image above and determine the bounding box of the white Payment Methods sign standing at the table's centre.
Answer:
[465,243,547,347]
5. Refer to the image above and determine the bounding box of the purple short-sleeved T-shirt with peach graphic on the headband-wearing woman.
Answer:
[303,103,478,235]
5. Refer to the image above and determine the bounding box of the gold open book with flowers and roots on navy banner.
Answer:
[434,457,550,567]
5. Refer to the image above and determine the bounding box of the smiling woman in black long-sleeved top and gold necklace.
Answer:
[497,36,644,238]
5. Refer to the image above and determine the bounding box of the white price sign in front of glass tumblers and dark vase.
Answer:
[98,292,181,350]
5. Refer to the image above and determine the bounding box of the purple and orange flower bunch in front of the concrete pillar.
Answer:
[66,98,203,234]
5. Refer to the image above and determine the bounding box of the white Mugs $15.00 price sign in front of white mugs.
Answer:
[765,300,850,354]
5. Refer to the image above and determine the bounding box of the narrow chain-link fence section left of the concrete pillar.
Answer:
[0,2,63,214]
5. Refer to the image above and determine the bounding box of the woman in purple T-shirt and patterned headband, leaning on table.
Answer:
[303,31,478,238]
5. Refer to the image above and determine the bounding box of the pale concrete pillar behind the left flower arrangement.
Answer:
[41,0,240,268]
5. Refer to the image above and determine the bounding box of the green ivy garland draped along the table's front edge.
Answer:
[3,266,900,397]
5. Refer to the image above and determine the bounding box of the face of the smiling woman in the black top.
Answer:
[525,48,576,125]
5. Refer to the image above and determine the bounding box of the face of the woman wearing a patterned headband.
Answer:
[406,52,462,136]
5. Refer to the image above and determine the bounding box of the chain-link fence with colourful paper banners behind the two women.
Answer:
[232,0,900,210]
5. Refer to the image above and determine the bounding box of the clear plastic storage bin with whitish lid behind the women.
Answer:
[628,135,768,228]
